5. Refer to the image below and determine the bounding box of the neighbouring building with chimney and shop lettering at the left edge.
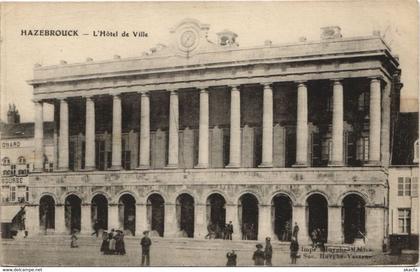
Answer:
[0,105,55,237]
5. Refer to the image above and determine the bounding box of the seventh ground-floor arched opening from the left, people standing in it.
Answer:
[206,194,226,239]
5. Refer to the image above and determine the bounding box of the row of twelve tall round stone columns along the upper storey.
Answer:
[35,78,381,170]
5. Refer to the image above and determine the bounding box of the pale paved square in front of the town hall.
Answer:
[1,237,418,266]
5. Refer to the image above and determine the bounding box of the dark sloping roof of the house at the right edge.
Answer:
[392,112,419,165]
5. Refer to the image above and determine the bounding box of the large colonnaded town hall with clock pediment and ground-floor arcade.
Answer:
[21,19,402,248]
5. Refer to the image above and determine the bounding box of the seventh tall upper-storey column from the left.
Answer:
[197,89,209,168]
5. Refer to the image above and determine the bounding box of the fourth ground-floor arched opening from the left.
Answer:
[118,194,136,236]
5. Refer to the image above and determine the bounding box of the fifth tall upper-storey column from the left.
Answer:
[139,93,150,169]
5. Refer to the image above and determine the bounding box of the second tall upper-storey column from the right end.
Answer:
[328,80,344,166]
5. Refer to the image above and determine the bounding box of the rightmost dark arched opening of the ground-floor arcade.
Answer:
[342,194,366,244]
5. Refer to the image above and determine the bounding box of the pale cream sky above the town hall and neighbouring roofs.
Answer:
[0,0,418,122]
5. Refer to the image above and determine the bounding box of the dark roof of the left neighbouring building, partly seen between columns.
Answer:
[0,122,54,140]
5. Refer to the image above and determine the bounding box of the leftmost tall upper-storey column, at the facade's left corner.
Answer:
[34,101,44,172]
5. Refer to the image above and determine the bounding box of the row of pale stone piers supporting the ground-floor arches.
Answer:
[25,203,384,248]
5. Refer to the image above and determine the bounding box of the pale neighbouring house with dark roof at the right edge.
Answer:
[389,112,419,249]
